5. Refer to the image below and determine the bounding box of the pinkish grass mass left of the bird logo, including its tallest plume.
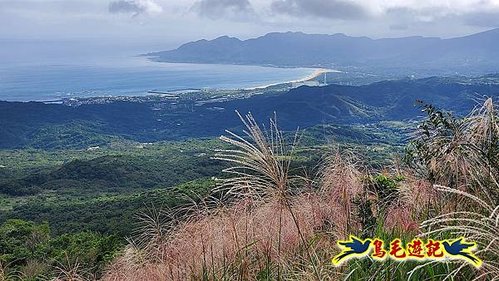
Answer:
[104,114,366,280]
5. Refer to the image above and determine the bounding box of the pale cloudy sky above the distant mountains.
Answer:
[0,0,499,52]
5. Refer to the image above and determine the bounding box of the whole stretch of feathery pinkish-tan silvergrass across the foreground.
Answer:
[103,98,499,281]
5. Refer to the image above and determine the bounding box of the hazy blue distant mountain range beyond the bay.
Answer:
[146,29,499,74]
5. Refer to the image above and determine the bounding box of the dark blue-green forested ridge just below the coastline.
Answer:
[0,75,499,149]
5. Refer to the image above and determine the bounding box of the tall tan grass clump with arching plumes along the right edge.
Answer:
[411,98,499,280]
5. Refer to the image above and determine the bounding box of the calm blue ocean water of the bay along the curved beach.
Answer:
[0,57,314,101]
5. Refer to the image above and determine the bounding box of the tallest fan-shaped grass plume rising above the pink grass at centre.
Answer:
[214,112,298,201]
